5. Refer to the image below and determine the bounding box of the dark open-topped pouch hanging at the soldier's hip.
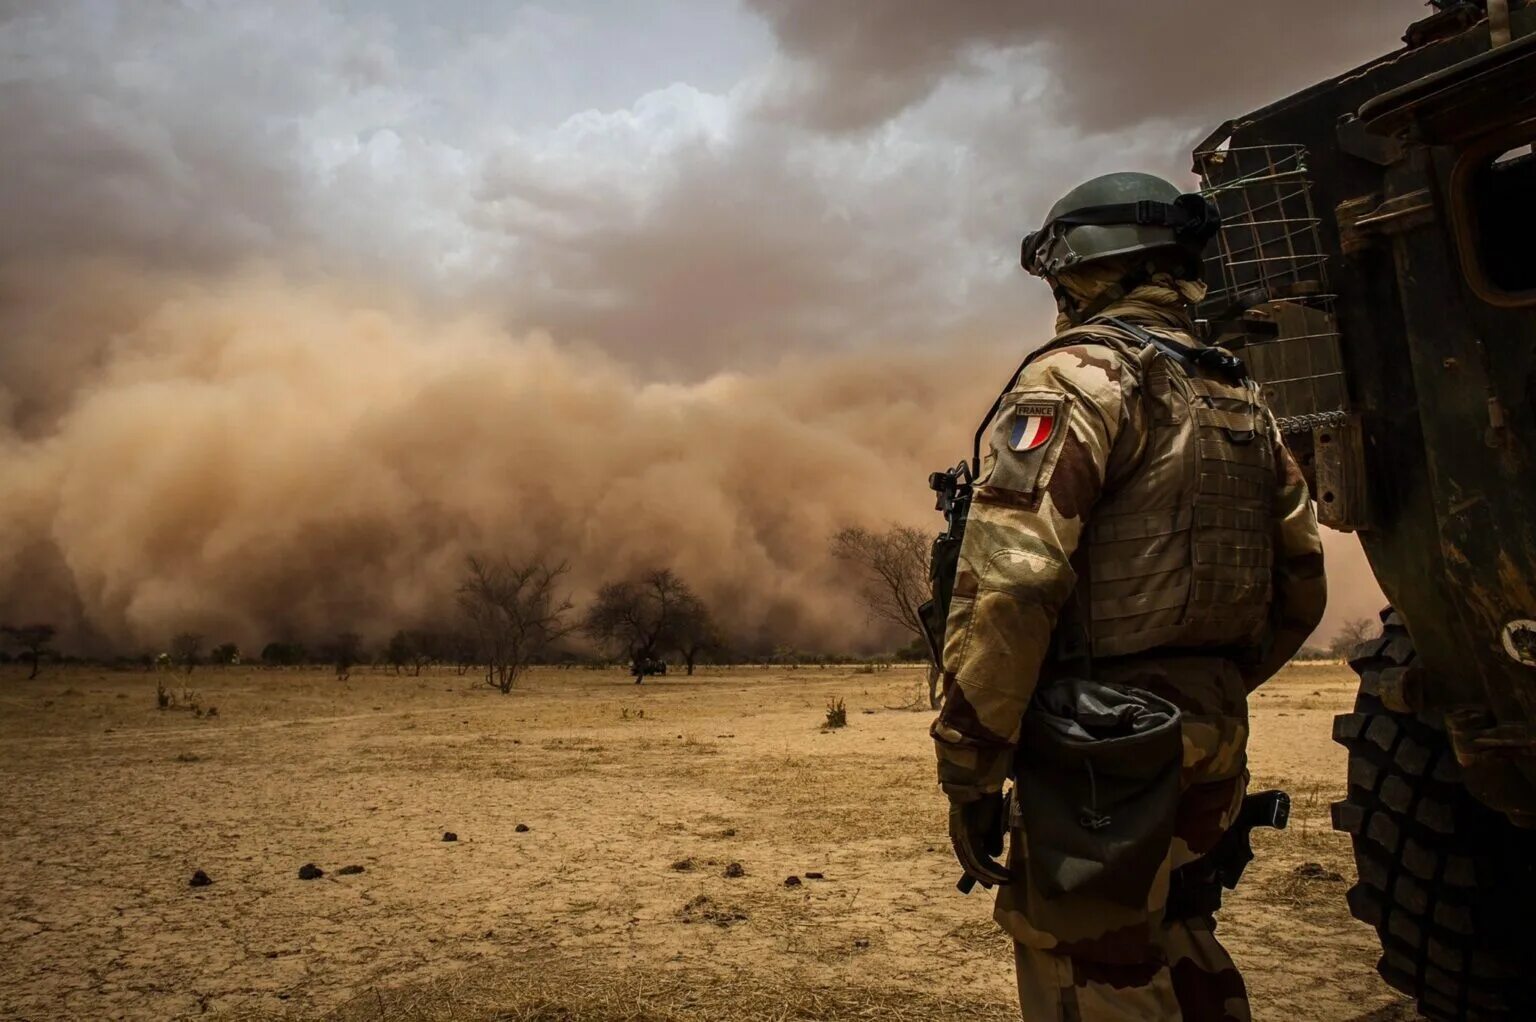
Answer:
[1014,678,1184,910]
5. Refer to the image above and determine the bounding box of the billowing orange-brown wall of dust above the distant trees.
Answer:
[0,259,980,649]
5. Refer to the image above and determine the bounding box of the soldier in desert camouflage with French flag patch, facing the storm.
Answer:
[932,174,1326,1022]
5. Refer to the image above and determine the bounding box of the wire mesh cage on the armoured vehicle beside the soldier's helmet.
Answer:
[1195,144,1349,432]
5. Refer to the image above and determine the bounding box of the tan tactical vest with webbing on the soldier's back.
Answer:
[1043,315,1275,658]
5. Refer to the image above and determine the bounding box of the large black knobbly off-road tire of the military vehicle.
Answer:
[1333,609,1536,1022]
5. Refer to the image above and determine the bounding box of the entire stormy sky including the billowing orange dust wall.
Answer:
[0,0,1394,649]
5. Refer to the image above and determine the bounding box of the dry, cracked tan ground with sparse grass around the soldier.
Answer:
[0,665,1412,1022]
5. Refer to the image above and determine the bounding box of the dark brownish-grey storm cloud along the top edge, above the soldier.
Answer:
[748,0,1422,131]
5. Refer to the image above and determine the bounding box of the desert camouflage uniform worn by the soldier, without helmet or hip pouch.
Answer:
[932,274,1326,1022]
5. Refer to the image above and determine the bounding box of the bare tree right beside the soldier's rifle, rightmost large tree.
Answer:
[833,526,938,708]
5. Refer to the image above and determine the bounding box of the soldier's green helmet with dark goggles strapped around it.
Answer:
[1021,172,1221,278]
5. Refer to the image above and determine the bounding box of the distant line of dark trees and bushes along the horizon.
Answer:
[0,526,932,682]
